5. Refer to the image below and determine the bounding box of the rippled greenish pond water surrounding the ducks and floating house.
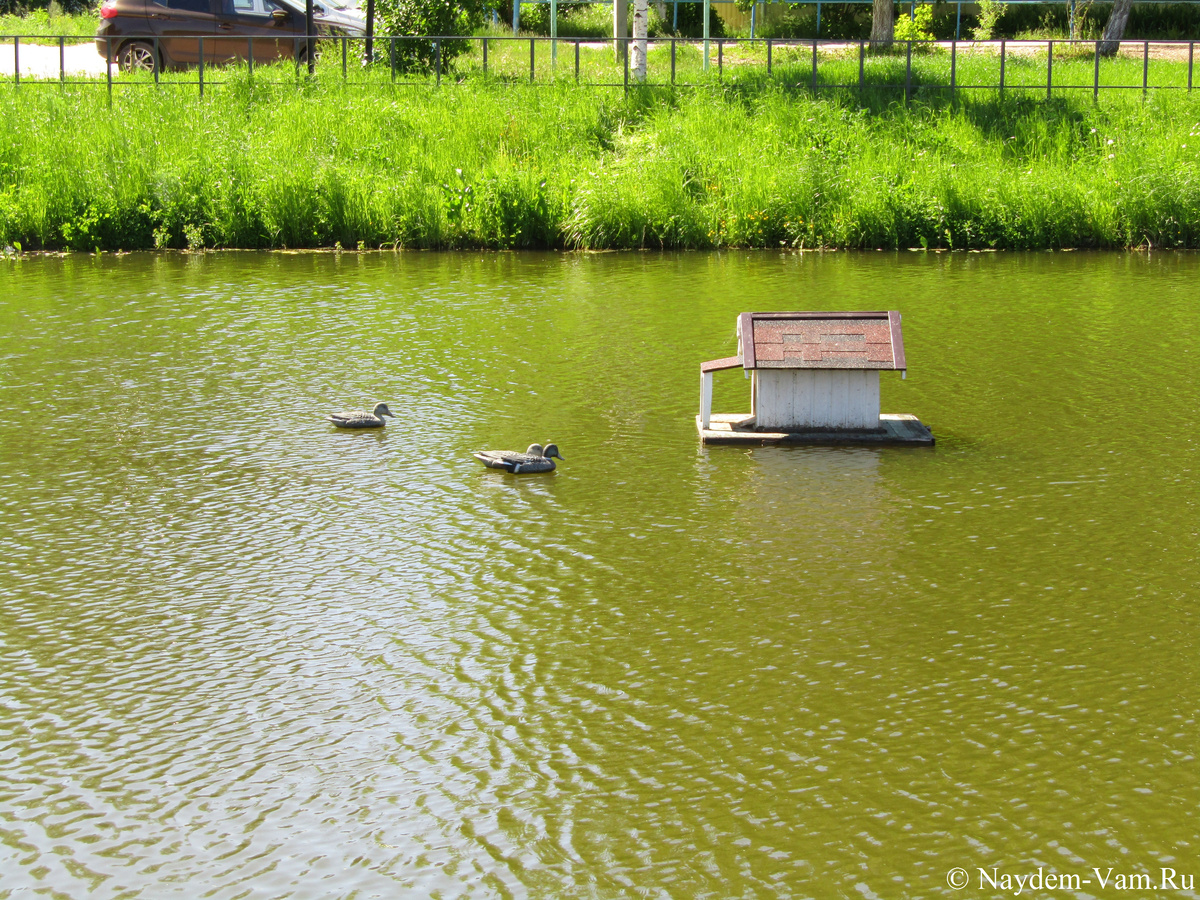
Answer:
[0,253,1200,899]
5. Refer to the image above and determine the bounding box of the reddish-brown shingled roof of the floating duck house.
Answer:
[738,311,906,370]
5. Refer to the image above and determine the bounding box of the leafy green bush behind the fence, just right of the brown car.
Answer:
[376,0,487,72]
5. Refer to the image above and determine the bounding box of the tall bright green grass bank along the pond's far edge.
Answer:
[0,65,1200,250]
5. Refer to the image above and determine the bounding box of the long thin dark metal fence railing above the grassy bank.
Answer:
[0,34,1196,101]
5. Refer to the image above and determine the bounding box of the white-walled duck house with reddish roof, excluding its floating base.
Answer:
[700,312,905,432]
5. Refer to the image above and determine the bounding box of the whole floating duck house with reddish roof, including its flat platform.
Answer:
[696,311,934,444]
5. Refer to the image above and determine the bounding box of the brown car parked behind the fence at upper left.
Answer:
[96,0,366,72]
